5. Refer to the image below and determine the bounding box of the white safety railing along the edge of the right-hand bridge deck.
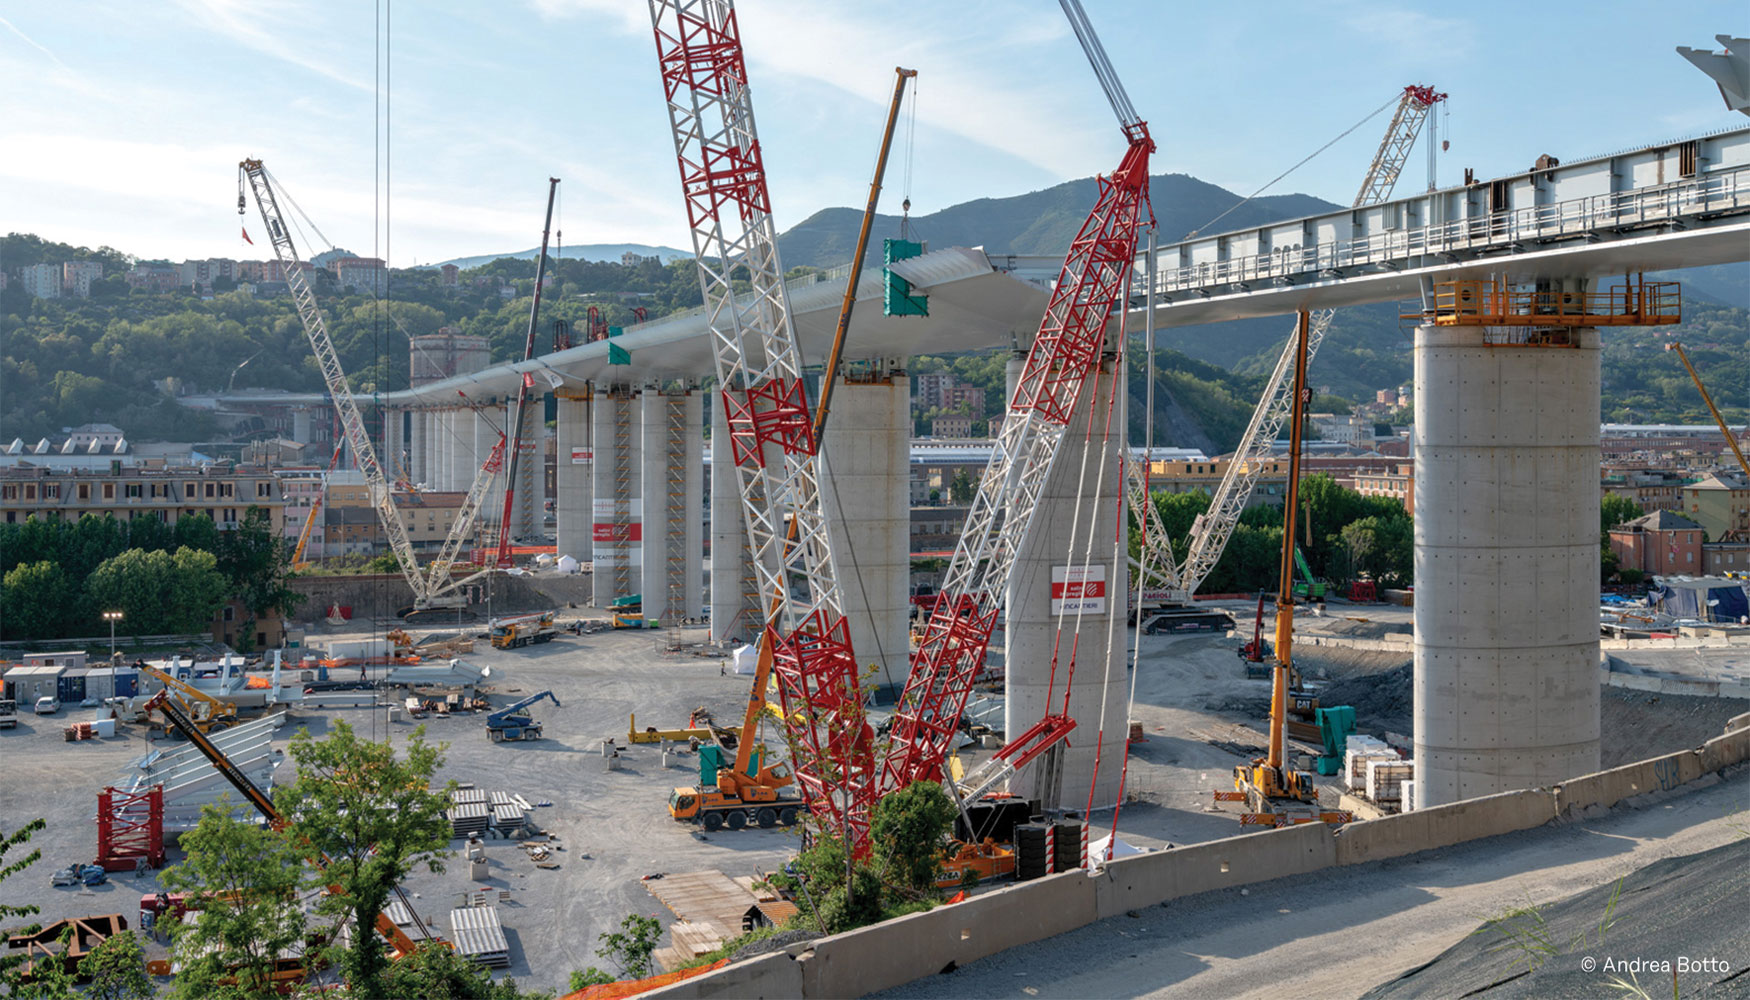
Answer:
[1155,166,1750,296]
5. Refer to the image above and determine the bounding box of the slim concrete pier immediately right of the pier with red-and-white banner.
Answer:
[637,387,705,620]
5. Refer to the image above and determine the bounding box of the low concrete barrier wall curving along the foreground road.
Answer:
[646,713,1750,1000]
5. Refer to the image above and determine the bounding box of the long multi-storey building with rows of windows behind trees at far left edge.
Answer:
[0,462,285,534]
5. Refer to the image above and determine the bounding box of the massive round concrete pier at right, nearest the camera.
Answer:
[1414,326,1600,807]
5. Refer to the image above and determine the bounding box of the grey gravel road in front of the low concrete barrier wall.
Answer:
[877,765,1750,1000]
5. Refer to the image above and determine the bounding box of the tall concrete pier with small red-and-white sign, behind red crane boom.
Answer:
[1003,363,1131,809]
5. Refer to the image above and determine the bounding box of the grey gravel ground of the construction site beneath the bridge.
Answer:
[0,604,1745,995]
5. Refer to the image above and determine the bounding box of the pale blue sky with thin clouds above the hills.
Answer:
[0,0,1750,266]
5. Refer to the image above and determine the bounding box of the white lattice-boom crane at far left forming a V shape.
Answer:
[236,159,504,613]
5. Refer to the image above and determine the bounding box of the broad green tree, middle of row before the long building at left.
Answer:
[86,546,229,632]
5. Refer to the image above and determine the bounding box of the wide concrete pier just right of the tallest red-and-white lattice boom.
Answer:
[821,373,912,688]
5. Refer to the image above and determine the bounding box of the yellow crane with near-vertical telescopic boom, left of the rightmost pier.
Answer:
[1215,310,1351,827]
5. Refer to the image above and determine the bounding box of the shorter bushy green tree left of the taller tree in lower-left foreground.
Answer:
[159,806,312,1000]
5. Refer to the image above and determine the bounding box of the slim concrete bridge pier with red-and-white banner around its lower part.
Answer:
[592,385,644,606]
